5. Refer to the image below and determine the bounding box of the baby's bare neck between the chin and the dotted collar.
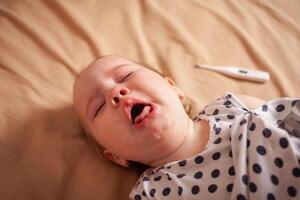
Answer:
[150,120,209,167]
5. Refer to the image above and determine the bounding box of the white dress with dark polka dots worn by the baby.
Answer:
[130,93,300,200]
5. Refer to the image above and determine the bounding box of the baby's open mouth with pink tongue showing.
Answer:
[130,103,152,124]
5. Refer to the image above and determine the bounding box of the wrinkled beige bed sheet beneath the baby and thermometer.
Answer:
[0,0,300,200]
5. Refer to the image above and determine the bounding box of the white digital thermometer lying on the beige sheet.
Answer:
[196,64,270,83]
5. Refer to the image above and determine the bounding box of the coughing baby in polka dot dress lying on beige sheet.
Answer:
[74,56,300,200]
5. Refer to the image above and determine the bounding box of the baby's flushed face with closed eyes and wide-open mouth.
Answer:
[74,56,187,164]
